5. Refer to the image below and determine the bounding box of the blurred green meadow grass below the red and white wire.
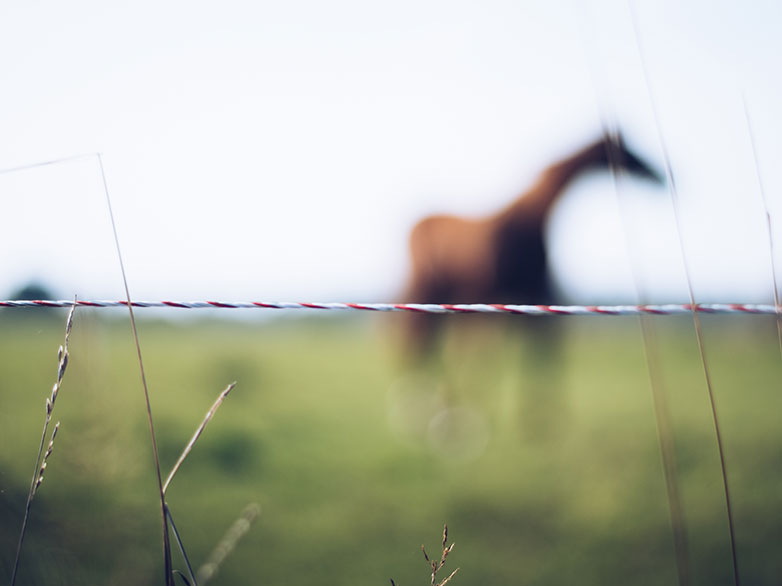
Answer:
[0,310,782,586]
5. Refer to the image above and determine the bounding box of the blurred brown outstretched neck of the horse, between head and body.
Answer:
[498,142,607,225]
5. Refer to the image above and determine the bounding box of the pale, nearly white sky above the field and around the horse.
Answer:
[0,0,782,303]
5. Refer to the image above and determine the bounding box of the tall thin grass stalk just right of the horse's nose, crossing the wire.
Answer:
[628,0,740,586]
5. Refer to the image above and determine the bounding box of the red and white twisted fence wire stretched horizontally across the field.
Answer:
[0,299,782,315]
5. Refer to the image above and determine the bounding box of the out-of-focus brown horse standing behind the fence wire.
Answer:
[404,135,662,357]
